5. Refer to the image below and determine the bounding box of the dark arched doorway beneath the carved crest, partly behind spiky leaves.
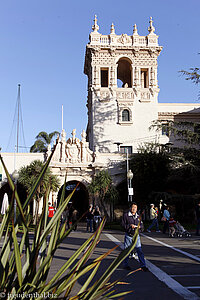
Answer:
[57,180,89,216]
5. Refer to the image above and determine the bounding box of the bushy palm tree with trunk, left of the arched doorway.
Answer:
[18,160,60,223]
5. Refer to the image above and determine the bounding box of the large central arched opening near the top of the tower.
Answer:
[117,57,132,88]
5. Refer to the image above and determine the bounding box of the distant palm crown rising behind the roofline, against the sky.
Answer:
[30,131,60,152]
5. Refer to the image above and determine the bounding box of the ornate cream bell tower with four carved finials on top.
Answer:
[84,16,162,153]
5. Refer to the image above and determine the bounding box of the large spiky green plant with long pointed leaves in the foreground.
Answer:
[0,142,138,300]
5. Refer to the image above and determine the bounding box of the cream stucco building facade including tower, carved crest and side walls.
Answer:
[1,17,200,212]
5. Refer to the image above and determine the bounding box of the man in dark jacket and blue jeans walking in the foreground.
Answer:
[122,202,148,272]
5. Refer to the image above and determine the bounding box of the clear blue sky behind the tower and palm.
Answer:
[0,0,200,152]
